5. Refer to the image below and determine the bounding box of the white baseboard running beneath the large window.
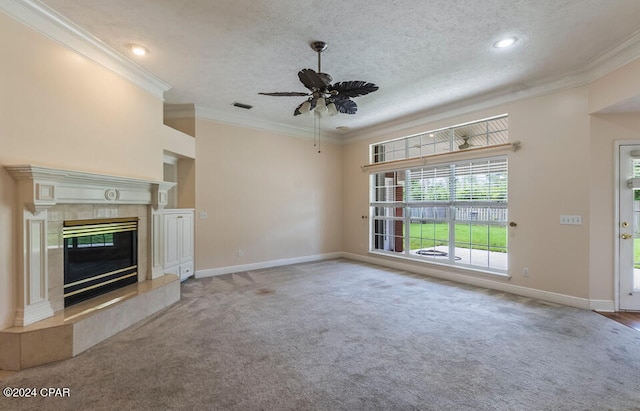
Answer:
[342,253,615,311]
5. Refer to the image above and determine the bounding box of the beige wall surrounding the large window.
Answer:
[344,87,591,298]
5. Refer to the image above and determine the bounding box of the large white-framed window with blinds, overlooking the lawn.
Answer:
[370,118,508,273]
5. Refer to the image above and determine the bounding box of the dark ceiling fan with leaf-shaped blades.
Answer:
[258,41,378,116]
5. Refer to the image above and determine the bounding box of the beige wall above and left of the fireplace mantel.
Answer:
[0,13,170,329]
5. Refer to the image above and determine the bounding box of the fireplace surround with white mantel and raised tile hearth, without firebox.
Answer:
[0,165,180,370]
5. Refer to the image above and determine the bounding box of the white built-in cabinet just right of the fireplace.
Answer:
[162,209,193,281]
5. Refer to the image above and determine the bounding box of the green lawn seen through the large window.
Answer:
[410,223,507,252]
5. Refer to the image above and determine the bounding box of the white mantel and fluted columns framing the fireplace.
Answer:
[5,165,175,326]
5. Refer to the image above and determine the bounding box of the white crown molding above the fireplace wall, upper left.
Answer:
[0,0,171,99]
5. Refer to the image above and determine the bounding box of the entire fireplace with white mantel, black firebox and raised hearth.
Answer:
[0,165,180,370]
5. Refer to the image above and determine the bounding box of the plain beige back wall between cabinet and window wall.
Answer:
[196,119,342,270]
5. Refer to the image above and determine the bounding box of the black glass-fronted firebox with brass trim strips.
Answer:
[62,218,138,307]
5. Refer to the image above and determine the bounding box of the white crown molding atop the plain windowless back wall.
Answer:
[196,106,344,144]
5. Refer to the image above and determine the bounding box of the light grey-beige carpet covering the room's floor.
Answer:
[0,260,640,410]
